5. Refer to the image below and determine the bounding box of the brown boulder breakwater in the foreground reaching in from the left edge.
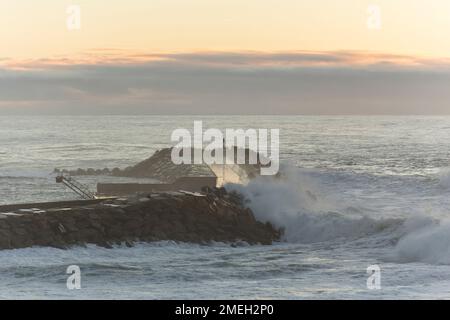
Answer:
[0,189,280,249]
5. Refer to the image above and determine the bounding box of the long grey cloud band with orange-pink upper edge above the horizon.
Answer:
[0,50,450,114]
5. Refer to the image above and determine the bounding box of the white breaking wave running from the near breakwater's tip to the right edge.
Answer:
[227,168,450,264]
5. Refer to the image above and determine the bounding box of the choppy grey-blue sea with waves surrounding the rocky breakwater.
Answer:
[0,116,450,299]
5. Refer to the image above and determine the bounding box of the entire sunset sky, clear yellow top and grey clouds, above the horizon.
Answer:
[0,0,450,114]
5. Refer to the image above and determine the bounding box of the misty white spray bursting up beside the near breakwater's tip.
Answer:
[227,166,403,243]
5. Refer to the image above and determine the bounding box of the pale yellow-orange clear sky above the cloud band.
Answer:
[0,0,450,60]
